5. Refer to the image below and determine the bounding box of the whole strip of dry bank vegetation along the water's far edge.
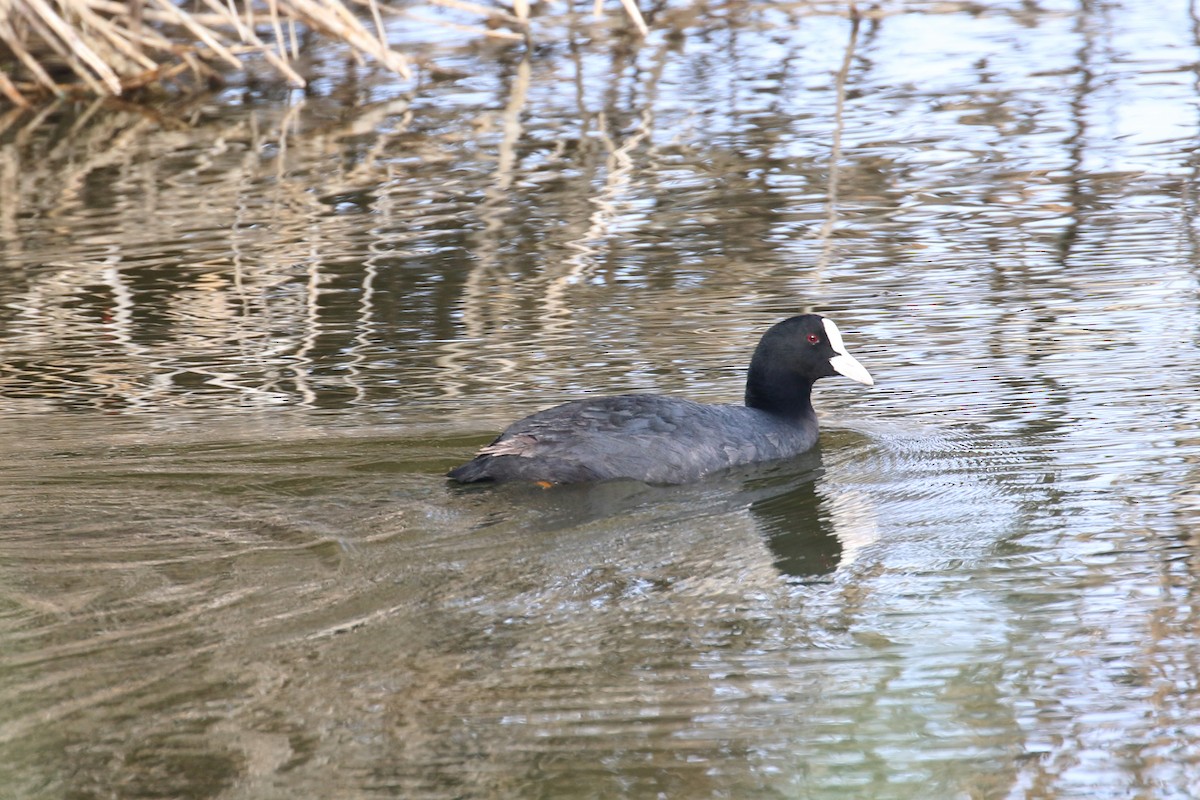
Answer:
[0,0,902,107]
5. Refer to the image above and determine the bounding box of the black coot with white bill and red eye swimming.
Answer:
[448,314,875,483]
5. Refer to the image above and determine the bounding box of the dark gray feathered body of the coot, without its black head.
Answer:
[450,395,817,483]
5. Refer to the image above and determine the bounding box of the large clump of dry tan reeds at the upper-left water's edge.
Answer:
[0,0,410,106]
